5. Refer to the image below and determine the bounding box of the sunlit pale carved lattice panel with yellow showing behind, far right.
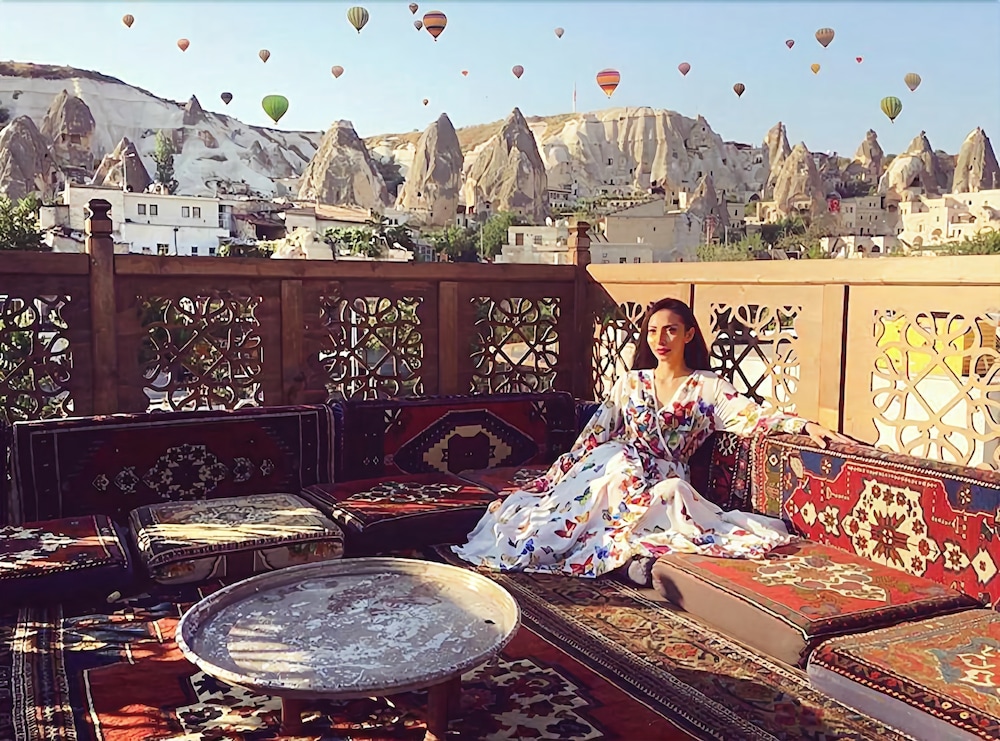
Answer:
[845,286,1000,469]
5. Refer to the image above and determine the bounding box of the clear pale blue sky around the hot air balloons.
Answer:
[0,0,1000,153]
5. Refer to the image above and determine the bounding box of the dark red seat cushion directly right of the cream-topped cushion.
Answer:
[303,473,497,555]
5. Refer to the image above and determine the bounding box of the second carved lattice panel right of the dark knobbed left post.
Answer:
[305,281,436,399]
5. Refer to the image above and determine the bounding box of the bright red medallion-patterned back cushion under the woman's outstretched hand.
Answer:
[753,437,1000,605]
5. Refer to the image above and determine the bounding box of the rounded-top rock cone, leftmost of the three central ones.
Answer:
[298,121,389,209]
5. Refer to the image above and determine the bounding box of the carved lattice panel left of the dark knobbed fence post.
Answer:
[0,276,91,424]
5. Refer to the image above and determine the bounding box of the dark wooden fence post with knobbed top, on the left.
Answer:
[84,198,118,414]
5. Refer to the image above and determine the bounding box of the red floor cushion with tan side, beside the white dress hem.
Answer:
[653,541,980,667]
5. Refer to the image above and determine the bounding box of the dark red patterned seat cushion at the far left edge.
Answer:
[0,515,132,607]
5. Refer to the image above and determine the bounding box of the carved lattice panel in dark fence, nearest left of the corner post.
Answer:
[460,294,572,394]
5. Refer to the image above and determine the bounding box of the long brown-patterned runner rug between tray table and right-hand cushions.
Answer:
[426,547,910,741]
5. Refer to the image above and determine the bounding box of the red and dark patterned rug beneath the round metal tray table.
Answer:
[0,586,692,741]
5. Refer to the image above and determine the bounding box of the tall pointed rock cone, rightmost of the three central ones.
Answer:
[464,108,548,223]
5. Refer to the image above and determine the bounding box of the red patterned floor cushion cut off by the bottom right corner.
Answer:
[807,610,1000,741]
